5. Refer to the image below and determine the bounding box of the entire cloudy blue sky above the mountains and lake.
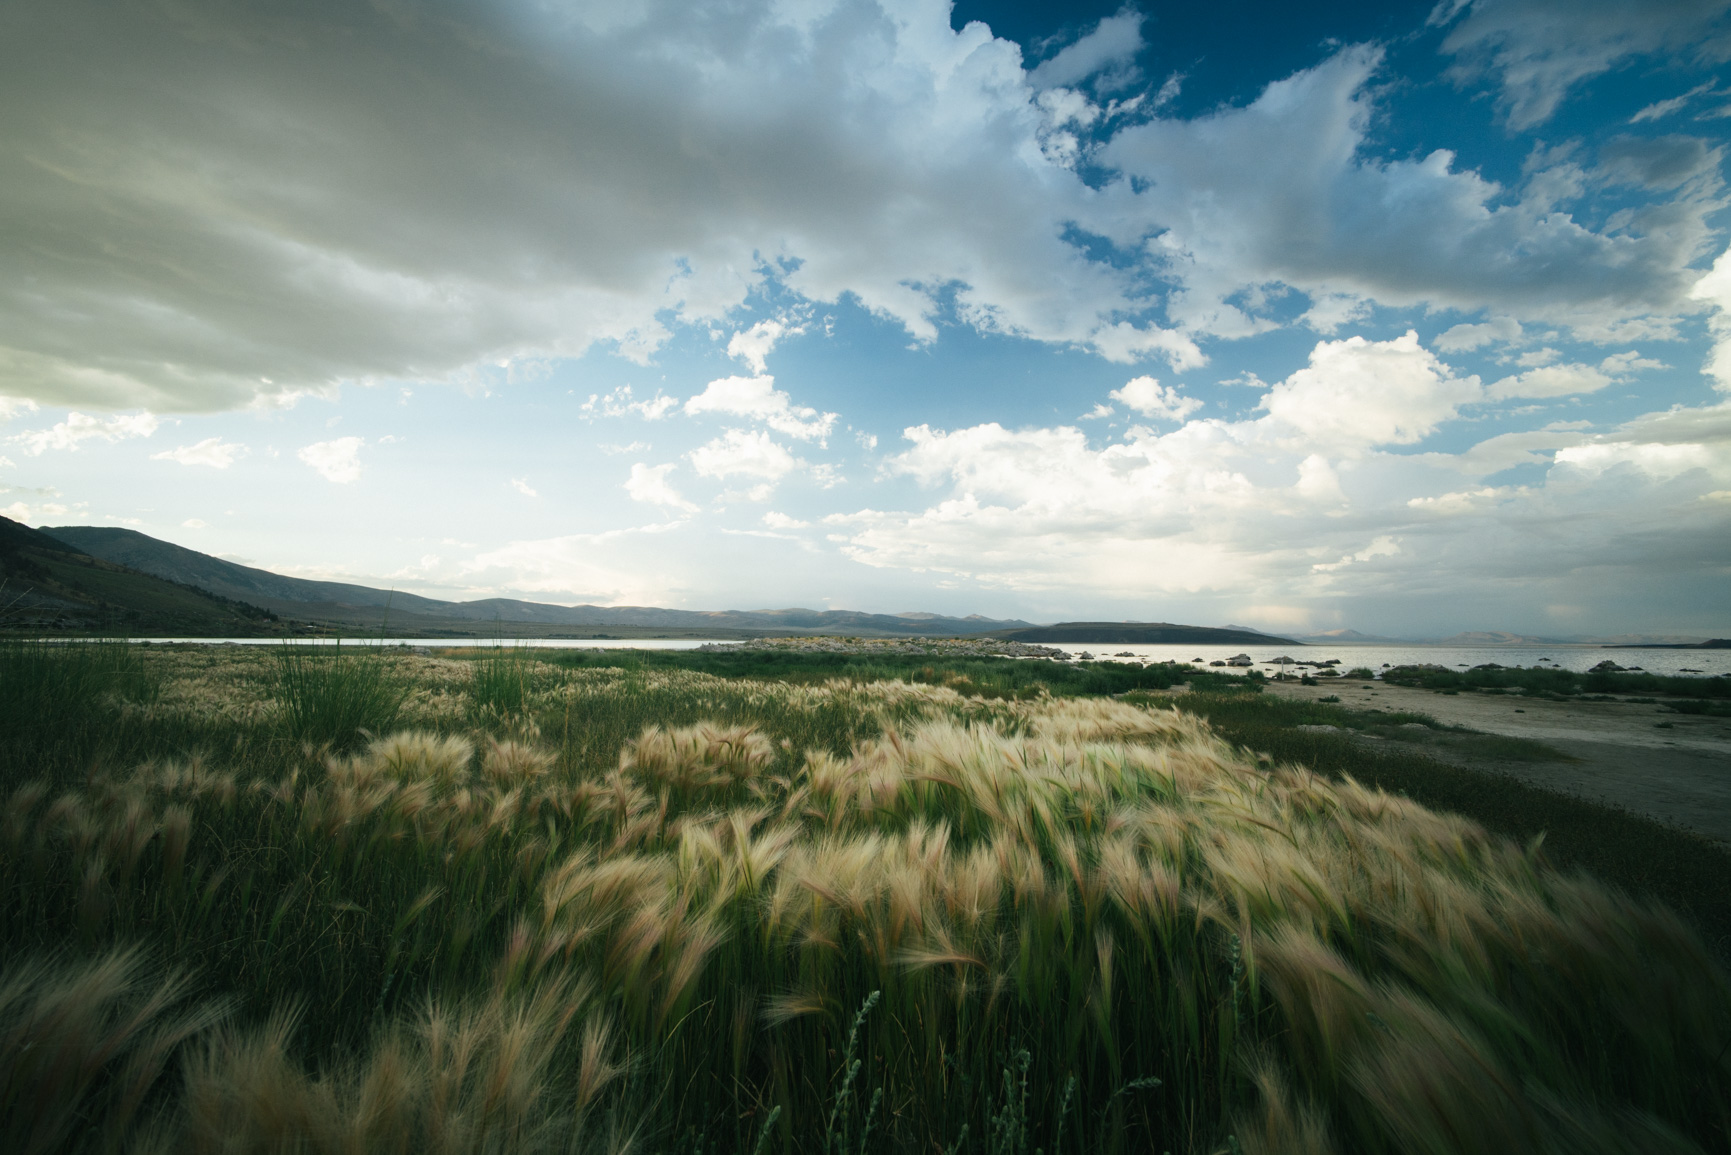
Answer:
[0,0,1731,637]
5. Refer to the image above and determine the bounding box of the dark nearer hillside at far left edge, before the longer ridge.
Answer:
[0,518,286,637]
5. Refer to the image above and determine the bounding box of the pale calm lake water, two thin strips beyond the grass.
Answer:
[122,637,1731,674]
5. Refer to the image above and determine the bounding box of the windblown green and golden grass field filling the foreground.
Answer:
[0,644,1731,1155]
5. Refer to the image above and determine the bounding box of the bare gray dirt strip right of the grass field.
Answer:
[1269,679,1731,843]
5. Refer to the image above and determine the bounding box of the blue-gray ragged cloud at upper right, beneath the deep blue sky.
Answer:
[1099,47,1719,338]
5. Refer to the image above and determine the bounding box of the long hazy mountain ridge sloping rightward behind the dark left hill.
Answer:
[42,525,1030,637]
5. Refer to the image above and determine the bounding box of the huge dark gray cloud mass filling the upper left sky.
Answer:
[0,2,1149,407]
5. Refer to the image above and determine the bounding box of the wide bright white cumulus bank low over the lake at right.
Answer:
[826,325,1731,620]
